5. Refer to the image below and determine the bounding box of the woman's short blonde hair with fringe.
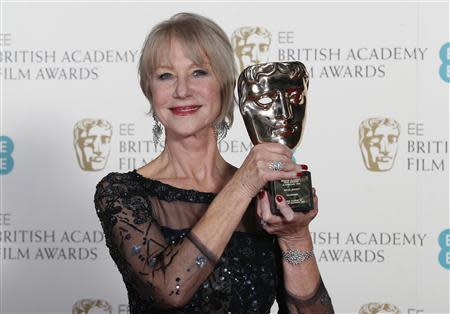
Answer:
[139,13,237,126]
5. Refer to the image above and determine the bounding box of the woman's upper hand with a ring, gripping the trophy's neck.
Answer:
[232,143,303,198]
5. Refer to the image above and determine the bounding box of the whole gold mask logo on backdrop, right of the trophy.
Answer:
[359,117,400,171]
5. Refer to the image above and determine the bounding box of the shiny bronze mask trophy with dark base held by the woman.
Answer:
[238,62,314,214]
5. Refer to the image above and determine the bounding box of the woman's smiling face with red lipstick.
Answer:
[150,40,221,137]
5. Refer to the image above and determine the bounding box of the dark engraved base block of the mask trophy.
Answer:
[267,171,314,215]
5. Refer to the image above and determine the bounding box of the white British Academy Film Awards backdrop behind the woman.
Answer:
[0,1,450,314]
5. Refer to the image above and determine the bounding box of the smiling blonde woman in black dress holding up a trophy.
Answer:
[95,13,333,313]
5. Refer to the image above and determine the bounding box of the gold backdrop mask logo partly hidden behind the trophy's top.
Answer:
[231,26,272,71]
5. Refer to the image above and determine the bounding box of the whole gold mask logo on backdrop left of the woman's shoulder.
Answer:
[73,119,112,171]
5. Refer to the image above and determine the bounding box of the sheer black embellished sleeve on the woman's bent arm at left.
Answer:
[95,173,216,308]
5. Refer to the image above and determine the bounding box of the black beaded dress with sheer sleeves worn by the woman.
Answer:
[95,171,333,314]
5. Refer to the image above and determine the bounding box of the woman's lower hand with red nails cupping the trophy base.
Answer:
[256,188,319,240]
